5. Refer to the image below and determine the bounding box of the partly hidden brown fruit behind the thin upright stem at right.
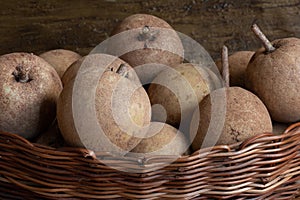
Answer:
[216,51,255,88]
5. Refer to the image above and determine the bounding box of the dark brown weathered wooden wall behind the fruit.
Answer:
[0,0,300,58]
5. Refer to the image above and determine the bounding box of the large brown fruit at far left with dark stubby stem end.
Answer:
[0,53,62,139]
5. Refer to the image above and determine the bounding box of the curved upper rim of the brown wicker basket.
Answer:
[0,122,300,162]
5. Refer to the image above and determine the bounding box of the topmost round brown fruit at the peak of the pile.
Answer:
[108,14,184,83]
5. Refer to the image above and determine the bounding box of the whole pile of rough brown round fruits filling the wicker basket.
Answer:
[0,14,300,156]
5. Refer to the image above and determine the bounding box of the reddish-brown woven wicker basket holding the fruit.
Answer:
[0,123,300,200]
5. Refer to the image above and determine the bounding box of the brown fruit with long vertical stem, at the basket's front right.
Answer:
[191,46,272,150]
